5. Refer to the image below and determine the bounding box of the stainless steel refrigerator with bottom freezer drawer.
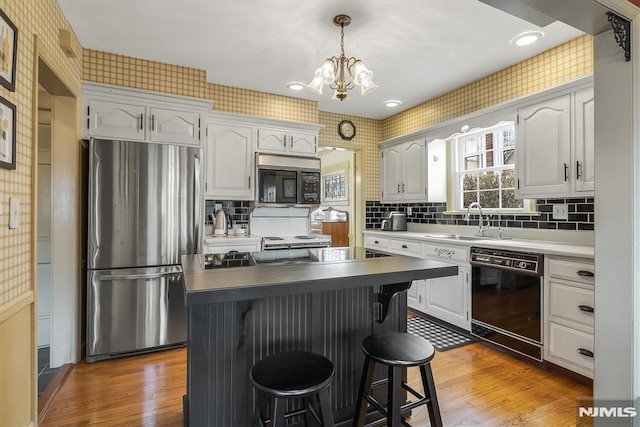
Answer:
[86,139,204,362]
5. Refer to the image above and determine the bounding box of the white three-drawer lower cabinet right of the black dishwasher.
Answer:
[544,257,595,378]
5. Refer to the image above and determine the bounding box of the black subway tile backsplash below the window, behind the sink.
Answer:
[366,197,594,230]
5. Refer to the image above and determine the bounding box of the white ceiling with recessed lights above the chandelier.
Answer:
[58,0,582,119]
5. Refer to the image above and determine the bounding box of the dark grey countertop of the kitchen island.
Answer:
[182,248,458,306]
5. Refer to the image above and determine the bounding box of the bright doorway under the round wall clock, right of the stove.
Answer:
[315,146,364,247]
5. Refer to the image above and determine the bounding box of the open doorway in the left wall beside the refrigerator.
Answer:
[33,57,81,408]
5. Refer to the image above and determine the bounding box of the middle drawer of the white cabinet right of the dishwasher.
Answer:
[549,282,594,328]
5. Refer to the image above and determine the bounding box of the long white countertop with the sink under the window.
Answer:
[363,230,594,258]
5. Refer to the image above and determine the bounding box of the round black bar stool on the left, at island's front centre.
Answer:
[251,351,335,427]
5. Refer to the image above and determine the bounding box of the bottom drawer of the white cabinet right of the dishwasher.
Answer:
[549,323,593,370]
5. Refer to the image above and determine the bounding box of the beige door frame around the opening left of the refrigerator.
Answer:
[31,35,82,419]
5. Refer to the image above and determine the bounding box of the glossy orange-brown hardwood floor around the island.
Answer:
[40,343,592,427]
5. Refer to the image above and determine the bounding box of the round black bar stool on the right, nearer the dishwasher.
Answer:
[353,332,442,427]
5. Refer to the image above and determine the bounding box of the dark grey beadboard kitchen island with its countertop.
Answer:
[183,248,458,427]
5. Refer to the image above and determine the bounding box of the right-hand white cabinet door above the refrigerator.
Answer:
[149,108,200,145]
